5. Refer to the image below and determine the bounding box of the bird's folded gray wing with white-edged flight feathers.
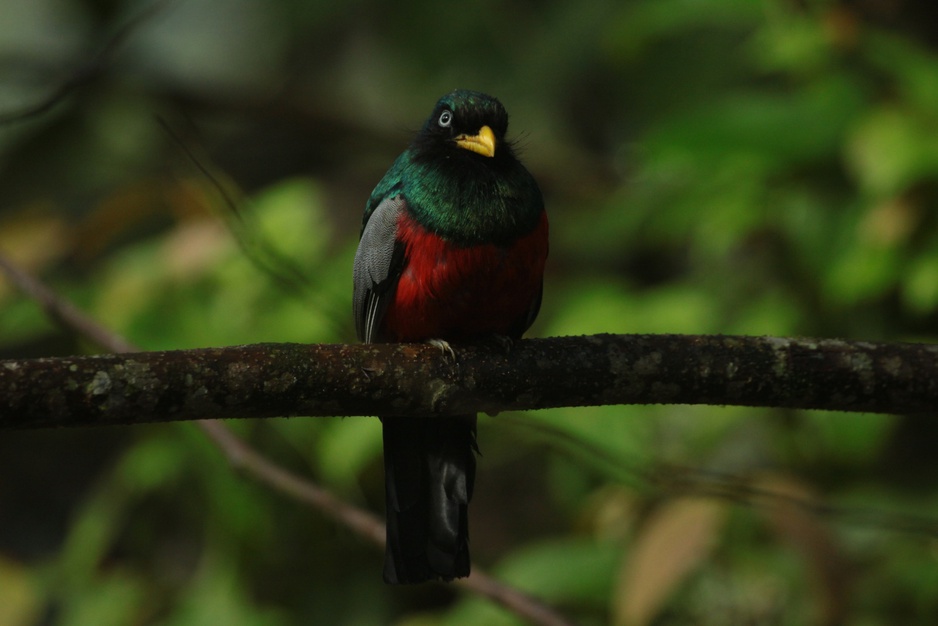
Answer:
[352,195,406,343]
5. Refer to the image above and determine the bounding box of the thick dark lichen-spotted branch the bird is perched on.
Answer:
[0,335,938,428]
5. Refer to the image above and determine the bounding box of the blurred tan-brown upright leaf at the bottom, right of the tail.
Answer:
[613,498,726,626]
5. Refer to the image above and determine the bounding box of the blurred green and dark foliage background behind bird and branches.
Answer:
[0,0,938,626]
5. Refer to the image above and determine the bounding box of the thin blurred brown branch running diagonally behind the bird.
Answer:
[0,254,575,626]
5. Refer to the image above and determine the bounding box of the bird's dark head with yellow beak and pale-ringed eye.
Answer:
[416,90,510,158]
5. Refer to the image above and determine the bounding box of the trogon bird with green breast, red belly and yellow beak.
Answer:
[353,90,548,583]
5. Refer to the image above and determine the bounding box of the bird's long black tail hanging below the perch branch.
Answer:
[382,415,477,584]
